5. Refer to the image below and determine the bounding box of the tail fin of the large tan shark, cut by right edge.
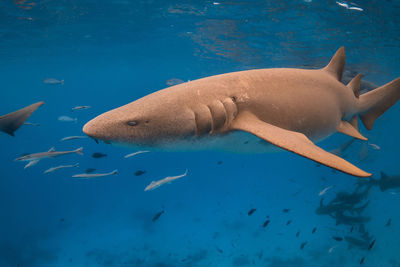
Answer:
[360,78,400,130]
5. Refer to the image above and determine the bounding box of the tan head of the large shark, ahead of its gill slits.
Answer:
[83,93,195,147]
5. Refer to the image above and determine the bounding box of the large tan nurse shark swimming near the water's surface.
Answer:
[83,47,400,177]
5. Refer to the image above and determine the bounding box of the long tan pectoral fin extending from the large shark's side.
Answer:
[231,112,371,177]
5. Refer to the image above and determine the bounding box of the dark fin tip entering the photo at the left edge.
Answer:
[0,102,44,136]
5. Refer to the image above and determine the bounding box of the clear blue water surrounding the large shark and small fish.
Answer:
[0,0,400,266]
